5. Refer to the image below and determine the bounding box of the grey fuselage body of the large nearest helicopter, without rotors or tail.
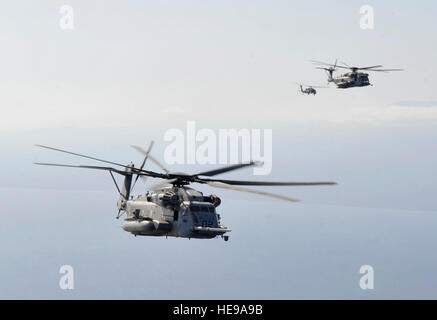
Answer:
[118,187,231,240]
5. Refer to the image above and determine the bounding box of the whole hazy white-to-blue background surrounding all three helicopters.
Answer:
[0,1,437,299]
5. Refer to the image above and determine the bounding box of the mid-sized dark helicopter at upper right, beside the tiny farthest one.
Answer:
[312,60,403,89]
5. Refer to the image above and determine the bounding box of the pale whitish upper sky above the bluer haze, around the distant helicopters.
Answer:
[0,0,437,131]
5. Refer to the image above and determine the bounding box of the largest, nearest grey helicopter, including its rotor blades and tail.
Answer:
[34,141,336,241]
